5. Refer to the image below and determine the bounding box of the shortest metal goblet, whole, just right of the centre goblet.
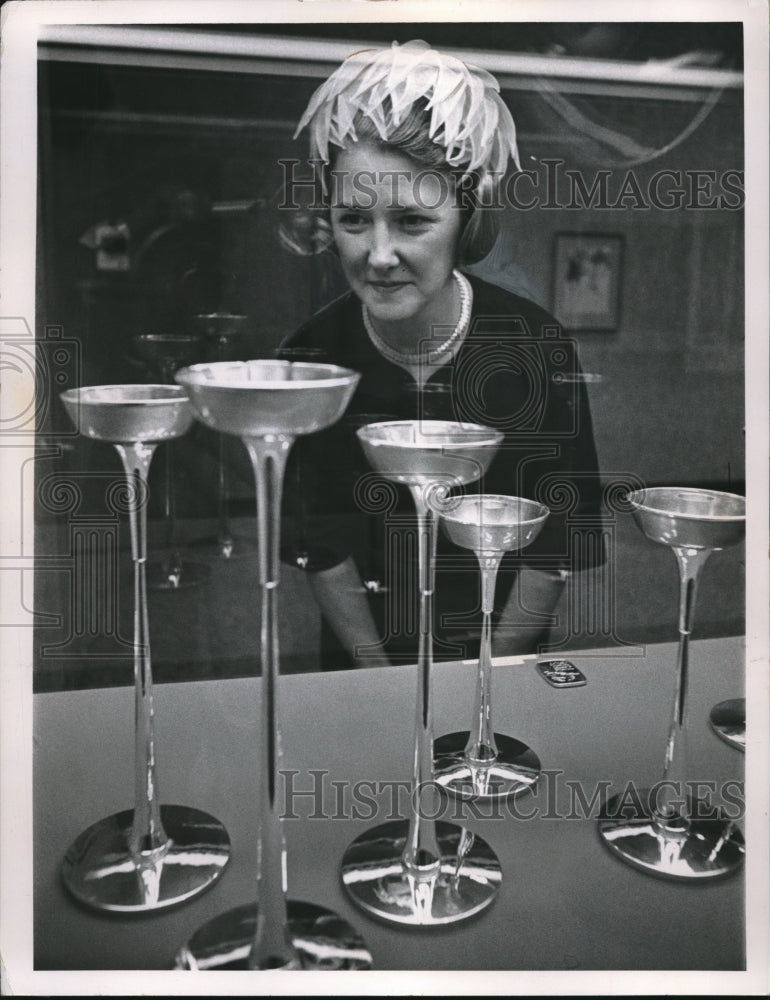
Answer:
[433,494,549,799]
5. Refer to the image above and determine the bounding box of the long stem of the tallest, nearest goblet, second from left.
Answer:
[244,434,301,969]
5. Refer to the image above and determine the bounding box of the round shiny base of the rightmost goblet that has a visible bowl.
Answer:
[599,789,745,881]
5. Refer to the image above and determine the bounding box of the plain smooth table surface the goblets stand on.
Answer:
[34,638,745,988]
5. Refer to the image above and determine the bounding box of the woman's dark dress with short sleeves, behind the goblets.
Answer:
[284,276,603,669]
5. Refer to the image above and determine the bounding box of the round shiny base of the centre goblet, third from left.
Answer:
[342,820,502,927]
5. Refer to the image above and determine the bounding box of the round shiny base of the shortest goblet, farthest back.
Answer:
[433,732,540,801]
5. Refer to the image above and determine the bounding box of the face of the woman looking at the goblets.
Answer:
[331,142,462,324]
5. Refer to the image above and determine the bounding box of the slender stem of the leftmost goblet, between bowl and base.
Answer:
[115,441,168,860]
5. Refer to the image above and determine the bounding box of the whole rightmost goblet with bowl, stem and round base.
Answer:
[599,487,746,879]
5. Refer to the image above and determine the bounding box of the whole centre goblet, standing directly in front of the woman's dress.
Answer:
[342,420,502,927]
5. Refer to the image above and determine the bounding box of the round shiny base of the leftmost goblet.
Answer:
[62,805,230,913]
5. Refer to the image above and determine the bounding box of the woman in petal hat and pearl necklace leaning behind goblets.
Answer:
[284,42,599,669]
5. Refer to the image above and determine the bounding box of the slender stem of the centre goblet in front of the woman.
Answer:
[402,486,441,880]
